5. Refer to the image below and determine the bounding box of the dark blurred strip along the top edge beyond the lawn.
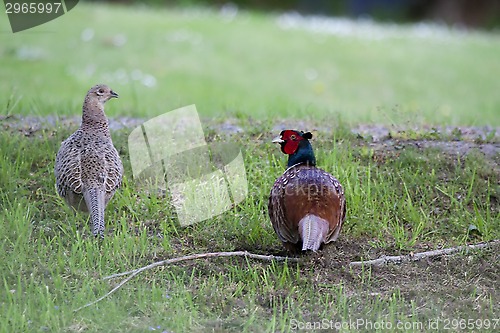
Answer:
[94,0,500,29]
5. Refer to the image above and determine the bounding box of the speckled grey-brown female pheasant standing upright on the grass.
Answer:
[54,84,123,237]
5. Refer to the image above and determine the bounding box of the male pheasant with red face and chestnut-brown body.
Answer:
[268,130,346,252]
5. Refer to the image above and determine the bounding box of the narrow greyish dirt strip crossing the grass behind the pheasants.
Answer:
[0,115,500,152]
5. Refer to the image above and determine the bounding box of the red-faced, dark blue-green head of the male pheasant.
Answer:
[273,130,316,167]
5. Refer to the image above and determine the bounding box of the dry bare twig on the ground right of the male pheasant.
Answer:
[349,239,500,266]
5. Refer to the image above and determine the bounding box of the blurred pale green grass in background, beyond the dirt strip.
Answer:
[0,3,500,126]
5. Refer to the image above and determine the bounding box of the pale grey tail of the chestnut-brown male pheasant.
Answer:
[299,214,329,252]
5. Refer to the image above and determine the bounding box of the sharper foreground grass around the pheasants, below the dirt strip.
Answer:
[0,123,500,332]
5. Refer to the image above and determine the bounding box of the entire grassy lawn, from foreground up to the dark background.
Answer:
[0,4,500,333]
